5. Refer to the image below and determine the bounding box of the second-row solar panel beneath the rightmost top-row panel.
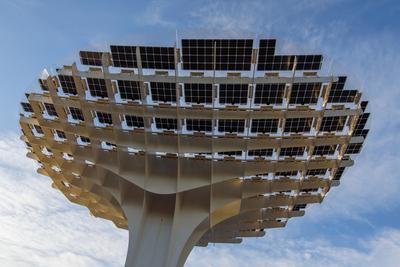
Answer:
[289,83,321,105]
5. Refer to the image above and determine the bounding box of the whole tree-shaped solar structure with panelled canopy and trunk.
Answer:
[20,39,369,267]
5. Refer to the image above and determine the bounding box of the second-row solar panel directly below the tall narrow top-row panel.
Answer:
[254,83,286,105]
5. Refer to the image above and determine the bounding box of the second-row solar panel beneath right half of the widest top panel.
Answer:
[219,84,249,105]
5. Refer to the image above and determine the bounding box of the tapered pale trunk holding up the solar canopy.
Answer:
[121,190,209,267]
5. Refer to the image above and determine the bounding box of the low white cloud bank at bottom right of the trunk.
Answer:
[186,229,400,267]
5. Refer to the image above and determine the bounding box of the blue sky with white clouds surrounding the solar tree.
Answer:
[0,0,400,267]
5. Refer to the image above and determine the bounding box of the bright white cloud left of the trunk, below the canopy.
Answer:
[0,134,128,267]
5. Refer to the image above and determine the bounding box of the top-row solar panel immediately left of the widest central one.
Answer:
[140,46,175,70]
